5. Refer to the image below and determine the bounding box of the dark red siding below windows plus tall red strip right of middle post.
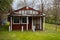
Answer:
[12,18,32,30]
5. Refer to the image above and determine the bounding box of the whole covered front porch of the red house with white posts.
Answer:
[10,16,43,31]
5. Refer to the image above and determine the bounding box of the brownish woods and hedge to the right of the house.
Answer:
[45,0,60,25]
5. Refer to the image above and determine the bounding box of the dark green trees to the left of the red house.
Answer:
[0,0,12,25]
